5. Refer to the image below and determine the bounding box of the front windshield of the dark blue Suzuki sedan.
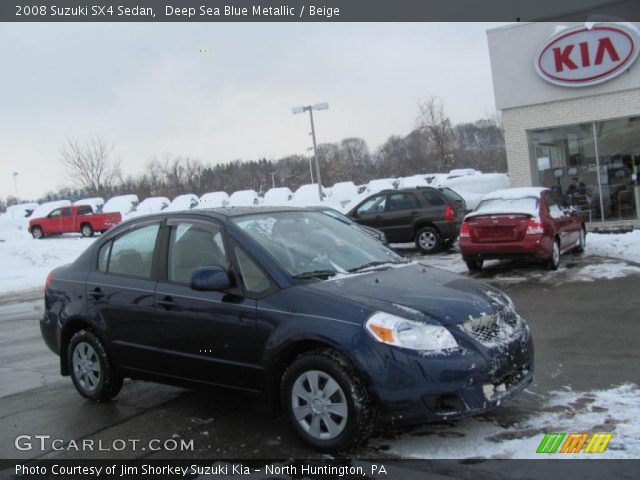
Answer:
[233,211,407,278]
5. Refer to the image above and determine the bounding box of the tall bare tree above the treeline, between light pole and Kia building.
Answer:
[418,97,454,171]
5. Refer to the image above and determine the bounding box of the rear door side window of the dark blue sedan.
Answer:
[106,223,160,278]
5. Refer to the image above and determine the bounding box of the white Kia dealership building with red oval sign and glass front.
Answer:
[487,22,640,222]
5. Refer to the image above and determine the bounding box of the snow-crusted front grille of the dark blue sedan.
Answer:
[460,308,523,347]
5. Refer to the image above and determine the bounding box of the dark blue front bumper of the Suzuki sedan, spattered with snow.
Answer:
[358,327,534,425]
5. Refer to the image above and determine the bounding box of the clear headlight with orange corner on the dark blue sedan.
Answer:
[365,312,458,352]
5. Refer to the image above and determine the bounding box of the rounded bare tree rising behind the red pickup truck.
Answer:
[60,137,121,195]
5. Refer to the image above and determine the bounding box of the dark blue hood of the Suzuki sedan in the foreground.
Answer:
[308,262,508,325]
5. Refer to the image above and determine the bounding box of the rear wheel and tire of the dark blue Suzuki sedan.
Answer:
[67,329,122,402]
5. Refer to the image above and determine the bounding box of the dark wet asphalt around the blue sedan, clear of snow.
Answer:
[0,265,640,459]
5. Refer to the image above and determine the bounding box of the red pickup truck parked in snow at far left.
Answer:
[29,205,122,238]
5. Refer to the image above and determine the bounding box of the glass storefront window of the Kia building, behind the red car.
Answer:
[527,117,640,221]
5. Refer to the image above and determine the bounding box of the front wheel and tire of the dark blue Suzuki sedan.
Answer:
[281,348,376,452]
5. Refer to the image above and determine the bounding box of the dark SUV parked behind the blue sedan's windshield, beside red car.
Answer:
[347,187,466,253]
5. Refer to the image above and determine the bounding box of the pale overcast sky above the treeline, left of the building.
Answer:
[0,23,510,199]
